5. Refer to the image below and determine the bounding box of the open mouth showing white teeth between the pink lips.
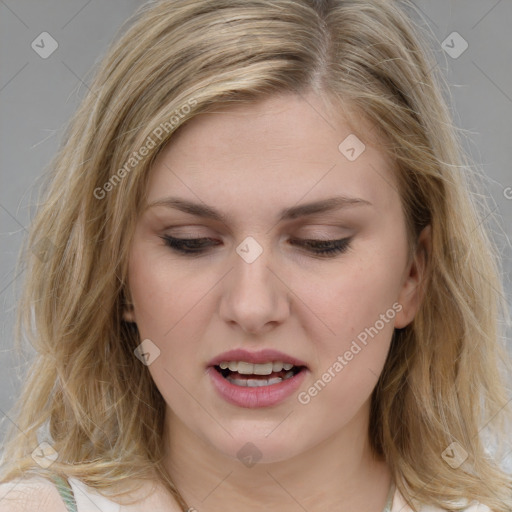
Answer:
[213,361,307,388]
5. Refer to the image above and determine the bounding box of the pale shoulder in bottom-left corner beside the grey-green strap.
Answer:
[0,476,67,512]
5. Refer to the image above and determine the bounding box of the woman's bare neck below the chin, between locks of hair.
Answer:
[165,404,391,512]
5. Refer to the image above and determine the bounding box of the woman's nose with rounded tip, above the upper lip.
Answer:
[219,240,291,334]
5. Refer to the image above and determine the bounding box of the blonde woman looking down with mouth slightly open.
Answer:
[0,0,512,512]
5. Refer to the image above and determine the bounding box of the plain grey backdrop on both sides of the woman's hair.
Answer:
[0,0,512,471]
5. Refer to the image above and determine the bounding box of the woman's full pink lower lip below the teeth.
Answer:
[207,366,307,409]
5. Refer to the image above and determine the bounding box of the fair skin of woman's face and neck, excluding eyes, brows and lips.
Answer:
[125,93,429,512]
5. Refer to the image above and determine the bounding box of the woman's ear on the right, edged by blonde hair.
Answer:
[395,224,432,329]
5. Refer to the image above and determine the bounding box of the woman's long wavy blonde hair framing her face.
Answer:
[1,0,512,512]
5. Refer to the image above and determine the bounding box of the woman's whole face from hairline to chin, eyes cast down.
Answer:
[125,94,428,462]
